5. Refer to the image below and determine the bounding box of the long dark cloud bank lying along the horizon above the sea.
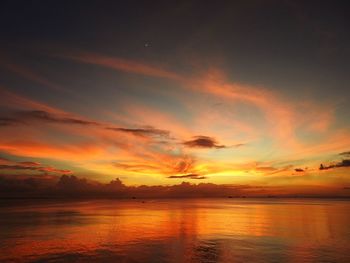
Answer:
[0,175,350,199]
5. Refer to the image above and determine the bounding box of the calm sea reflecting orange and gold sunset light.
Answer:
[0,198,350,263]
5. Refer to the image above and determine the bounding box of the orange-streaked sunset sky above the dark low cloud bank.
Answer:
[0,0,350,196]
